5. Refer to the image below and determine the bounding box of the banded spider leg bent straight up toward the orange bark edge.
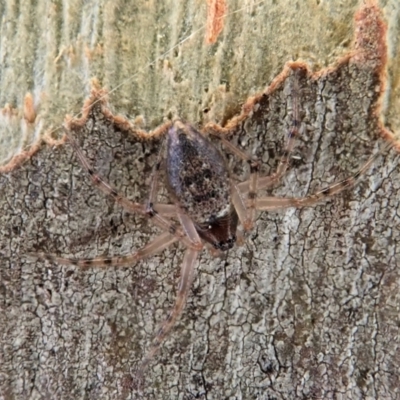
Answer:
[237,70,300,196]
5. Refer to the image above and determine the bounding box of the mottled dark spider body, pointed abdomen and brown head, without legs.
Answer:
[167,121,237,249]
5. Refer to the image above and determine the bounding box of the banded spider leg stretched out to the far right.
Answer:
[252,142,392,211]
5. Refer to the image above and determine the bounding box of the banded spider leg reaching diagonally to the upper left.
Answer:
[65,129,201,249]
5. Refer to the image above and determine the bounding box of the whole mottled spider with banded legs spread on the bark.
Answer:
[29,63,389,388]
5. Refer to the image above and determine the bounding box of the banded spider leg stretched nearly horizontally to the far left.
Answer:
[28,232,178,268]
